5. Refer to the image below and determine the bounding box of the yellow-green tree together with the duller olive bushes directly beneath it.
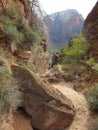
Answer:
[57,34,89,75]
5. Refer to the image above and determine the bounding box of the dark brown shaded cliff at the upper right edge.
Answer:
[82,2,98,59]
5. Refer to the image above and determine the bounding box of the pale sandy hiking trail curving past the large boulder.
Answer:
[53,83,90,130]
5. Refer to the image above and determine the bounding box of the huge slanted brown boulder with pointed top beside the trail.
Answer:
[11,64,75,130]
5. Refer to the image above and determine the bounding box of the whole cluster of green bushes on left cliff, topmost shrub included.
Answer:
[0,3,40,49]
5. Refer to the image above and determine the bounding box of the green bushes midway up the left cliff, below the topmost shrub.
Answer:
[0,16,40,48]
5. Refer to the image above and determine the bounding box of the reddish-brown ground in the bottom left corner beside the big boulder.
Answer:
[0,110,33,130]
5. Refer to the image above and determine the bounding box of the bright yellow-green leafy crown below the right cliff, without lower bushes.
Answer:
[58,34,88,63]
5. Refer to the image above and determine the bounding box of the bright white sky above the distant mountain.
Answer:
[39,0,97,18]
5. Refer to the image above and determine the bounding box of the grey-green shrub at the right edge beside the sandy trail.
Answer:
[85,83,98,111]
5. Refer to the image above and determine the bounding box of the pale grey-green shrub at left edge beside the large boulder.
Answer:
[0,57,21,118]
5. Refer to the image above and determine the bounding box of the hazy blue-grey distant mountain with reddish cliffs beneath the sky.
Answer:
[45,9,84,48]
